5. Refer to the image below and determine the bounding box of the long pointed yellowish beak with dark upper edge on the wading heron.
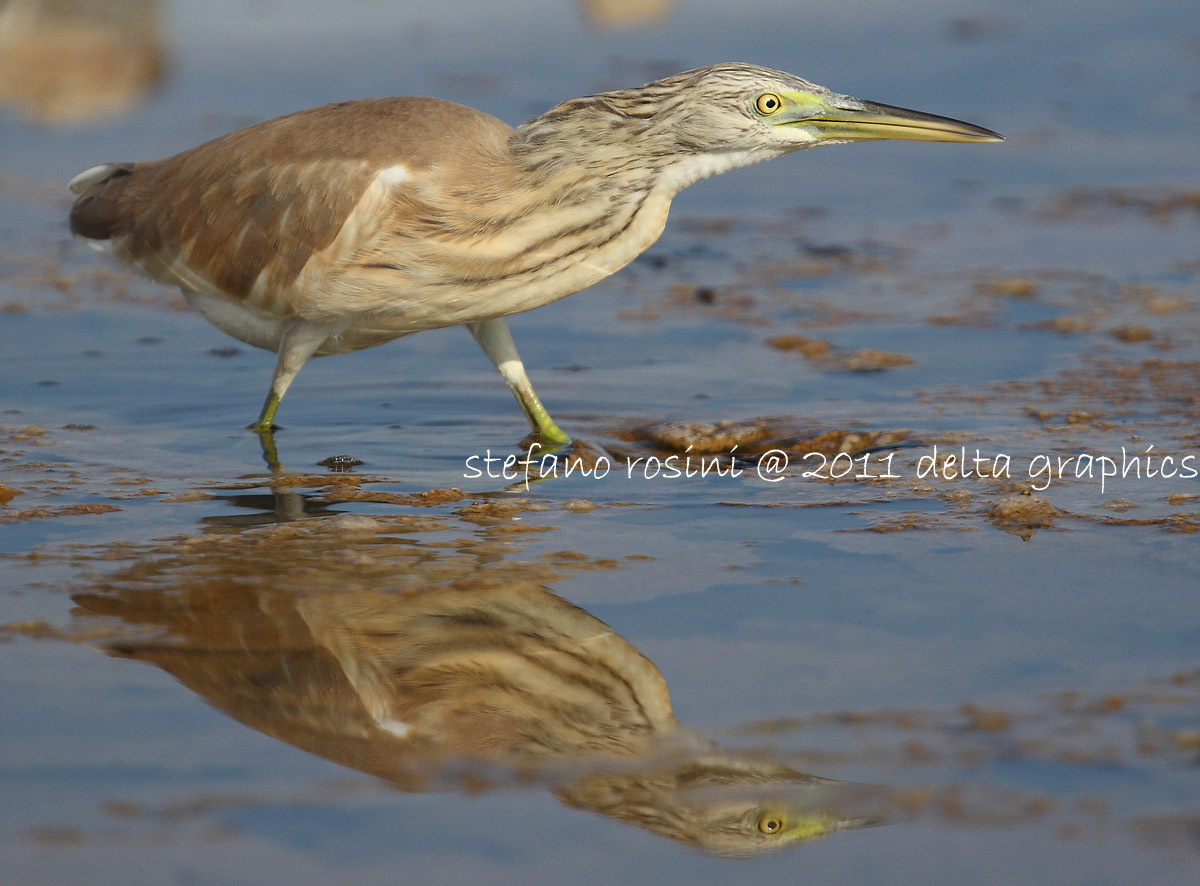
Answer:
[796,95,1004,142]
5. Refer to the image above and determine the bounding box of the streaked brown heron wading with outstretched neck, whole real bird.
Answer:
[71,64,1000,443]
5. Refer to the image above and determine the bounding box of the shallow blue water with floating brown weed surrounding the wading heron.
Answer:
[0,0,1200,884]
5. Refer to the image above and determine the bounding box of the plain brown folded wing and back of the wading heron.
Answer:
[71,98,511,315]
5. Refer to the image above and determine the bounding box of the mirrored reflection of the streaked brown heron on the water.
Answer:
[76,543,874,855]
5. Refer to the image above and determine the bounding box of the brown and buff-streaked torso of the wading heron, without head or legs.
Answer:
[71,88,696,340]
